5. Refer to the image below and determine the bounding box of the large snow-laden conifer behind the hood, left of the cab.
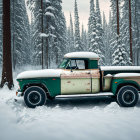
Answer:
[44,0,67,67]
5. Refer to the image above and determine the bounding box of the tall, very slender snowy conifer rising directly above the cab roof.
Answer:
[74,0,83,51]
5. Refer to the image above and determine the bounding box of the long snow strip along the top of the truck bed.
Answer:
[101,66,140,71]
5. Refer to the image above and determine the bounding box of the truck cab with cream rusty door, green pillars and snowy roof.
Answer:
[59,53,100,95]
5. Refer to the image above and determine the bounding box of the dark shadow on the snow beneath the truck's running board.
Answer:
[46,97,115,108]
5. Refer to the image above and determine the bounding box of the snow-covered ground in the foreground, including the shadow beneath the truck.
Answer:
[0,67,140,140]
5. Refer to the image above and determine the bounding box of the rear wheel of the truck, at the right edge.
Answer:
[117,86,139,107]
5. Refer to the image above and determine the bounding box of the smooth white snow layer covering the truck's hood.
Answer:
[17,69,62,79]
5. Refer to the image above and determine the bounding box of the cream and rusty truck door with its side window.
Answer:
[61,60,91,95]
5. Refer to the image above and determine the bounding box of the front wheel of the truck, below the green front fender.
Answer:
[24,86,47,108]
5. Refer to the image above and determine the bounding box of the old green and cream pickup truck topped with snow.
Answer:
[16,52,140,108]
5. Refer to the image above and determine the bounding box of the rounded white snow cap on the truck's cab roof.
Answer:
[64,52,100,60]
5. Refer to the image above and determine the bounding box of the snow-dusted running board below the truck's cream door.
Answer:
[56,92,114,98]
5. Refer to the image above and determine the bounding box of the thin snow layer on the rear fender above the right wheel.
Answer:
[113,73,140,78]
